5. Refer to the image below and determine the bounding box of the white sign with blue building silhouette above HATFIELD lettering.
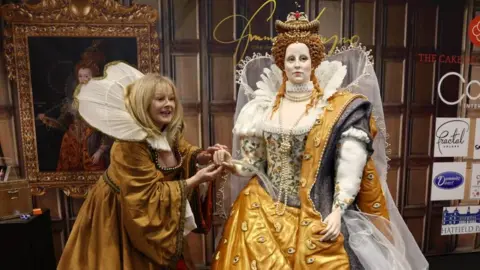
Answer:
[442,205,480,235]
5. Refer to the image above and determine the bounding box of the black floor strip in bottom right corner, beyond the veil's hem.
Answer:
[427,252,480,270]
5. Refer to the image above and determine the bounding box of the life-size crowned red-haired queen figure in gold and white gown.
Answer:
[212,12,428,270]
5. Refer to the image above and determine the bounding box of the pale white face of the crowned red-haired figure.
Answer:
[285,43,312,84]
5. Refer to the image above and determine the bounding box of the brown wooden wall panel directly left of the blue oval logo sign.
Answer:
[407,167,429,206]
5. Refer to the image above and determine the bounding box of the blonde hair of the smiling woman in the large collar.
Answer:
[125,73,184,146]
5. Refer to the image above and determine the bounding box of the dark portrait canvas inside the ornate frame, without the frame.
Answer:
[28,37,137,172]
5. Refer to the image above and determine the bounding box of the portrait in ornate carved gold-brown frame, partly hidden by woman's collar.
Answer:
[2,0,160,197]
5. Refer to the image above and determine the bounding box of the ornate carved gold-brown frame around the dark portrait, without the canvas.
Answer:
[2,0,160,197]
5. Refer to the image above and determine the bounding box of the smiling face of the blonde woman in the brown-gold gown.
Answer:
[149,87,175,130]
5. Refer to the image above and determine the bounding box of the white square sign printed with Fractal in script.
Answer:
[434,117,470,157]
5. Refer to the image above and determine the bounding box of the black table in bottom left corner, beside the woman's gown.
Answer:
[0,209,56,270]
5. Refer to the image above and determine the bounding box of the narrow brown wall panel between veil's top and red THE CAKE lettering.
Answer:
[384,60,404,103]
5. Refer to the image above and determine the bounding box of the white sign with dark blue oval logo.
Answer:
[430,162,467,201]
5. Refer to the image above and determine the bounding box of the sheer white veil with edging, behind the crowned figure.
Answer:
[225,44,428,270]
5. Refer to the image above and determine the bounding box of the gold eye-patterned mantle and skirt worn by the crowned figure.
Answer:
[212,91,388,270]
